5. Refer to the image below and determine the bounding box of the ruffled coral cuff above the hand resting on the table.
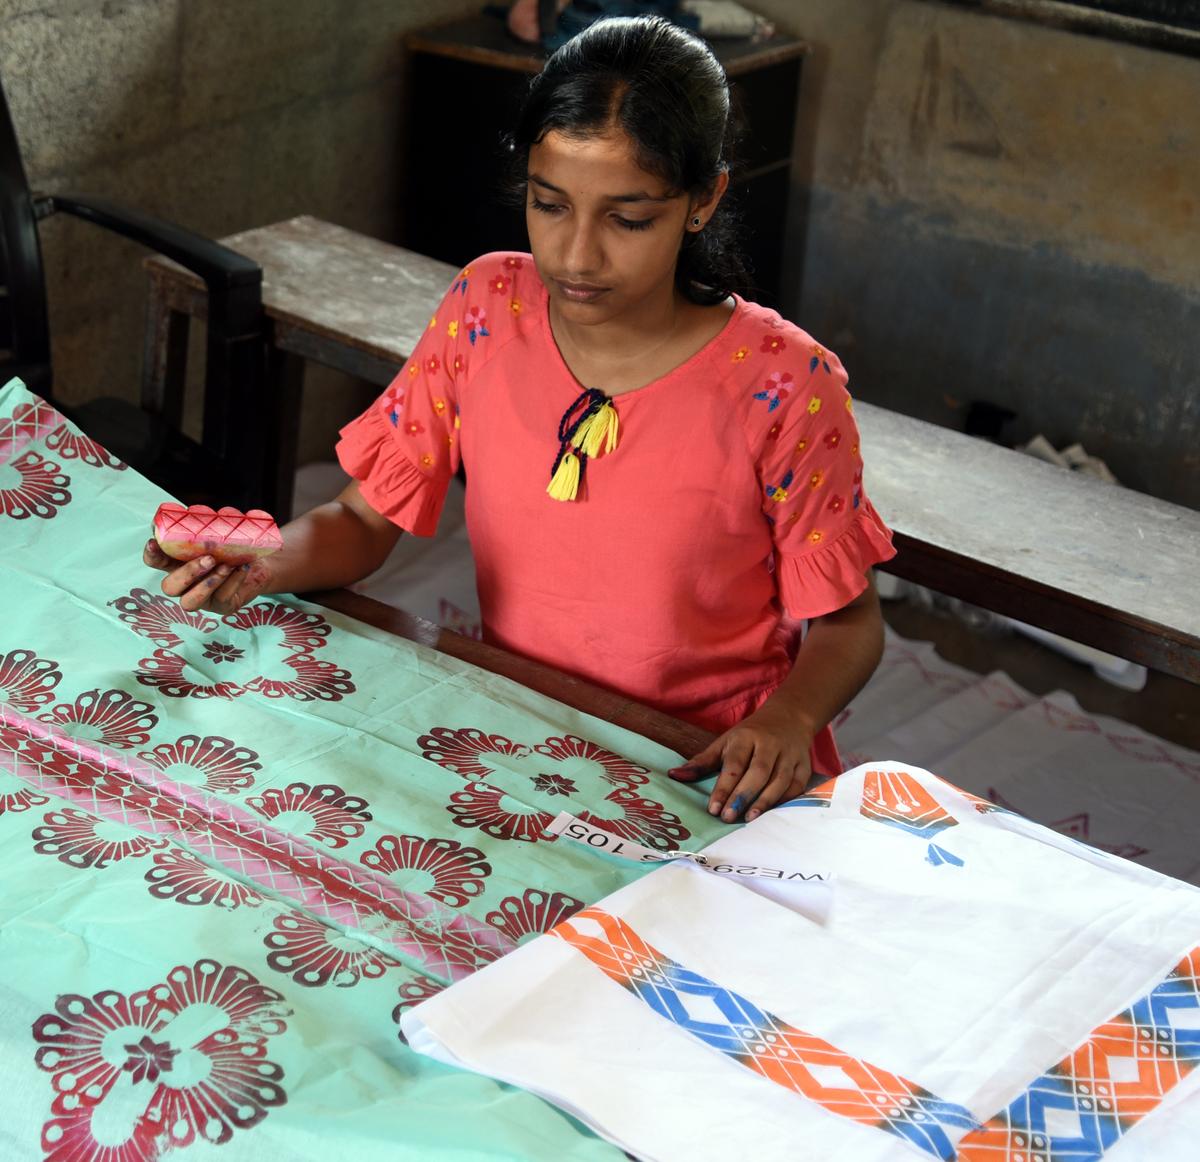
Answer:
[775,496,896,621]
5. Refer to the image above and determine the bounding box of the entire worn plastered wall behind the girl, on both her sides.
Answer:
[0,0,1200,505]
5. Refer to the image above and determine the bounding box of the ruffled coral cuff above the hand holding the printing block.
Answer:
[336,405,449,537]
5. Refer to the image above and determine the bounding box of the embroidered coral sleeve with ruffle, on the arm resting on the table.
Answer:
[750,329,895,618]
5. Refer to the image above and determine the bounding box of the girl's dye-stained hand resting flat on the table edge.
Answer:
[667,701,814,823]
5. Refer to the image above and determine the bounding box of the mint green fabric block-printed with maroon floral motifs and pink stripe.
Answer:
[0,381,724,1162]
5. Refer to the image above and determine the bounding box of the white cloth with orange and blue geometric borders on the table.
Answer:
[402,762,1200,1162]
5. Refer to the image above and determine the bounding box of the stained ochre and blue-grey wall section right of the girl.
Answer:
[755,0,1200,507]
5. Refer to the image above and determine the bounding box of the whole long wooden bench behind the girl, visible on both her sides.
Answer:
[143,217,1200,682]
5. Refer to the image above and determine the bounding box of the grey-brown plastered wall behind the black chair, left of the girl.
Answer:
[0,0,478,459]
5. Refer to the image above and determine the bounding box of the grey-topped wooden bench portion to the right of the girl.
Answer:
[854,401,1200,682]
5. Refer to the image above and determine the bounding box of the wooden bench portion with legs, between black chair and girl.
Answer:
[142,216,457,520]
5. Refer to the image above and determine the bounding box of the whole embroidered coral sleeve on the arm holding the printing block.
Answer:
[337,254,529,537]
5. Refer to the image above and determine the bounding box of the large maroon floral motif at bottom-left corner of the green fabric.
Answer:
[34,960,290,1162]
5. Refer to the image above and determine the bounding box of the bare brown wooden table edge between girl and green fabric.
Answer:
[314,589,714,759]
